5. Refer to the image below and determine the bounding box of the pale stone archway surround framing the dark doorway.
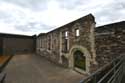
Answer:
[69,45,91,74]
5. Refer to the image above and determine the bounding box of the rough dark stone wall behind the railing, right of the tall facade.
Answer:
[95,21,125,67]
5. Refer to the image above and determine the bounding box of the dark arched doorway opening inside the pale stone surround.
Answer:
[74,50,86,70]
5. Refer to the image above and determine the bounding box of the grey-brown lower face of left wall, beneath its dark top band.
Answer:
[3,38,34,55]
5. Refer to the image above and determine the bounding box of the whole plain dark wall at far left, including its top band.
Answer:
[0,33,35,55]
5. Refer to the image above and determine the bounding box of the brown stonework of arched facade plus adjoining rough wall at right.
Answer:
[36,14,125,74]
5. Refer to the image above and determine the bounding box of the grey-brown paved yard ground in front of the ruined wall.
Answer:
[6,55,84,83]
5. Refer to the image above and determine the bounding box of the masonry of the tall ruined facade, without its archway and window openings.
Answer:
[37,14,95,70]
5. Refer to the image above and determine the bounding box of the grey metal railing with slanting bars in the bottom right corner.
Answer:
[80,55,124,83]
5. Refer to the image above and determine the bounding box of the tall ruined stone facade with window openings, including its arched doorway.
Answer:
[36,14,96,74]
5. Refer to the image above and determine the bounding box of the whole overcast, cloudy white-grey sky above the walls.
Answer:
[0,0,125,35]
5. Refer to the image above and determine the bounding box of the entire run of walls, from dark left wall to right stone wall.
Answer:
[0,14,125,74]
